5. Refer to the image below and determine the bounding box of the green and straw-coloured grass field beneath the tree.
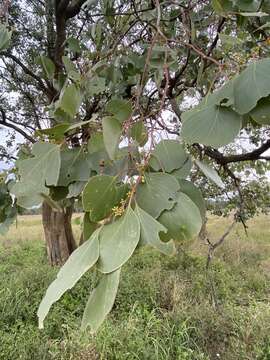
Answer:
[0,216,270,360]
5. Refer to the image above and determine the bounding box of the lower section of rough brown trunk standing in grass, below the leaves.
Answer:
[42,202,76,266]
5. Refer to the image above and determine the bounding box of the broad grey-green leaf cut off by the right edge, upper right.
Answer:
[234,58,270,114]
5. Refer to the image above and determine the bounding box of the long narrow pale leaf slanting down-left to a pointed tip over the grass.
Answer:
[37,228,101,329]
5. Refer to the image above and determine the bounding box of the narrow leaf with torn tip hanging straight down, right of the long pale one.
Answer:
[81,269,121,333]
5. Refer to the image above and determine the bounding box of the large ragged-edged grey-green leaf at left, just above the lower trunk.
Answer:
[11,142,61,208]
